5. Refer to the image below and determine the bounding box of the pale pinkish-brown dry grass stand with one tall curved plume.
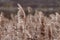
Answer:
[0,4,60,40]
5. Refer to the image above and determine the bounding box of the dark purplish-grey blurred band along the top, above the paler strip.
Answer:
[0,0,60,8]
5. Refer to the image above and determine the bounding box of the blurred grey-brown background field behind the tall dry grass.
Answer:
[0,0,60,14]
